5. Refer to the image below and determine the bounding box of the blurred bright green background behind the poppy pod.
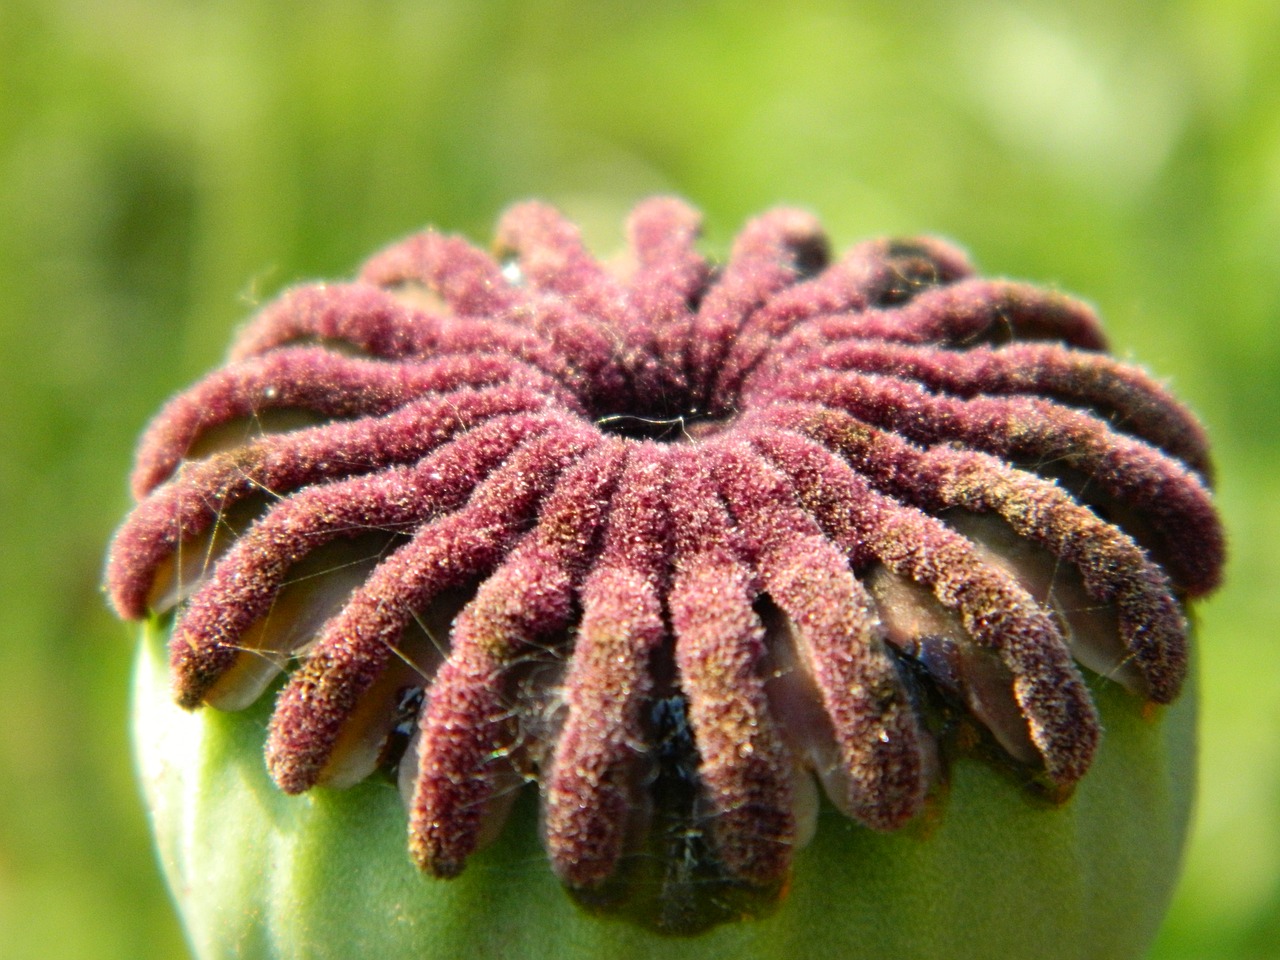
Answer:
[0,0,1280,960]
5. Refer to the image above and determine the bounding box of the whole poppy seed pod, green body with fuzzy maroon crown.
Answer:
[108,198,1222,960]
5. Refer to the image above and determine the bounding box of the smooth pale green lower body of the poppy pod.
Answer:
[134,631,1196,960]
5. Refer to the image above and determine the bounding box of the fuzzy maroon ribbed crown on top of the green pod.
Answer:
[108,197,1224,936]
